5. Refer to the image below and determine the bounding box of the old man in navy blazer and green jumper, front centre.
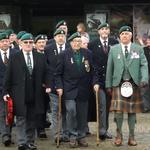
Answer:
[55,32,92,148]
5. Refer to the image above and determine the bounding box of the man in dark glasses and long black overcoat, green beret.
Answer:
[3,33,50,150]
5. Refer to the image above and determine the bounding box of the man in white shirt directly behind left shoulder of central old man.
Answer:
[45,29,69,141]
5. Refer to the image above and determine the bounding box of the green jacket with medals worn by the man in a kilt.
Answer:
[106,43,148,88]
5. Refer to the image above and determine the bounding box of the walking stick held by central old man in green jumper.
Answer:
[57,94,61,148]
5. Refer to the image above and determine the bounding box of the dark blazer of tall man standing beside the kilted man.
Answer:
[89,38,118,88]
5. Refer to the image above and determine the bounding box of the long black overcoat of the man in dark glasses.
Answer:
[3,51,49,116]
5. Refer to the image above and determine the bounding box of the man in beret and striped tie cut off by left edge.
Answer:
[0,32,17,146]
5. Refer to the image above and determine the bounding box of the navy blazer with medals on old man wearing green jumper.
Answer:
[55,48,93,101]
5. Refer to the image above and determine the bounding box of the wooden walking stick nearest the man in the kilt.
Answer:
[96,90,100,146]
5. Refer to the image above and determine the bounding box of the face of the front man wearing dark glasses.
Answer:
[21,40,33,52]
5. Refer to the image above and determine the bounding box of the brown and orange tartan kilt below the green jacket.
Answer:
[110,86,144,113]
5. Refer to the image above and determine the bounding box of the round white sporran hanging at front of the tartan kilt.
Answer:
[121,81,133,98]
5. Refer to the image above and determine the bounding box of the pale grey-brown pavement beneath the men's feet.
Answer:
[0,113,150,150]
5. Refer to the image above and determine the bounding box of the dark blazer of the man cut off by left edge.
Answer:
[0,49,18,93]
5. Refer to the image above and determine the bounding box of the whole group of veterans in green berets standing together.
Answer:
[0,20,150,150]
